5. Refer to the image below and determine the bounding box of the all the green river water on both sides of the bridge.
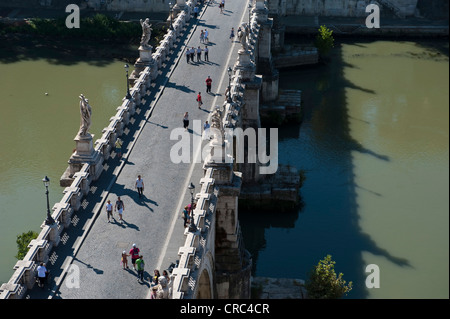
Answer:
[0,41,449,298]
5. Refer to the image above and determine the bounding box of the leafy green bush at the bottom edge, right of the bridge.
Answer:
[305,255,353,299]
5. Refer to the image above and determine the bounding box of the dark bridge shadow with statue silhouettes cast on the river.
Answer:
[239,43,411,299]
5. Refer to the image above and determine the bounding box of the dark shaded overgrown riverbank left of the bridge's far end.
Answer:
[0,14,166,64]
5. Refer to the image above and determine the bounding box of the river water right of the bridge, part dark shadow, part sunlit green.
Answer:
[240,41,449,298]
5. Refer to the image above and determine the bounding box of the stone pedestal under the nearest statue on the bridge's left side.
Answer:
[60,133,103,187]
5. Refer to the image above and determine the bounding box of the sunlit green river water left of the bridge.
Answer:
[0,43,126,282]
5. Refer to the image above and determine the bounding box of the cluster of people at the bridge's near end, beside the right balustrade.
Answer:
[120,244,172,299]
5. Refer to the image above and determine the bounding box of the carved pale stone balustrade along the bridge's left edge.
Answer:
[0,0,200,299]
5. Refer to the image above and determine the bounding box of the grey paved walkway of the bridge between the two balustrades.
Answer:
[28,1,248,299]
